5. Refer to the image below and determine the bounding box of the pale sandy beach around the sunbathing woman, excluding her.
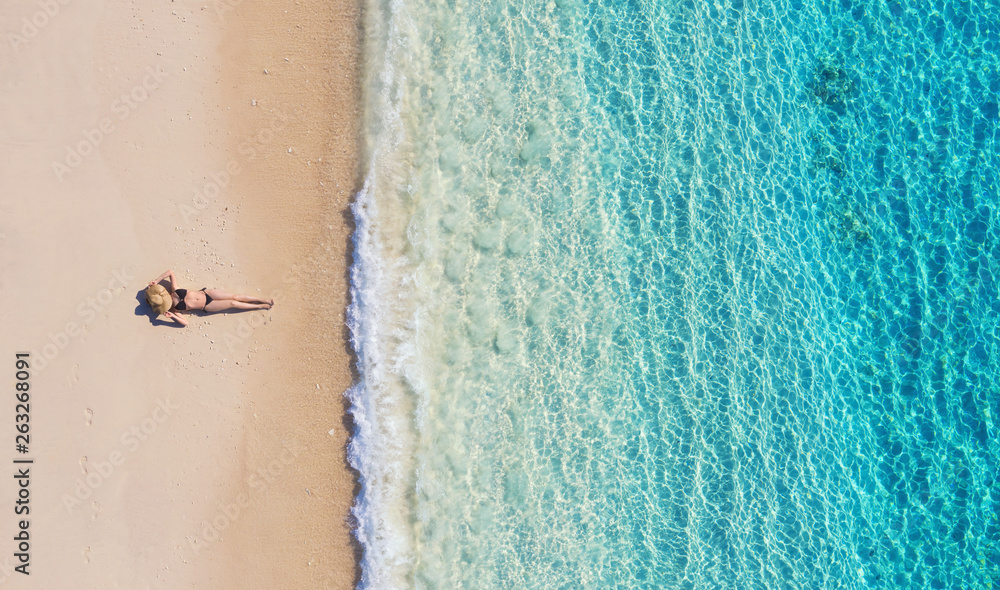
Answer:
[0,0,361,589]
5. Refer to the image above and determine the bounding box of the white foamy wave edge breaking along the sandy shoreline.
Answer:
[345,0,414,590]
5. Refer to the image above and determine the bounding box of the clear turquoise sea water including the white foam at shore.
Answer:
[348,0,1000,589]
